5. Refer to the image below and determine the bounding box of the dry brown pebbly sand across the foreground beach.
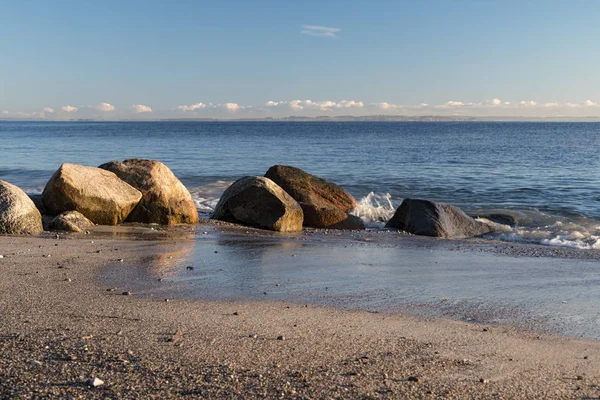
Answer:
[0,235,600,399]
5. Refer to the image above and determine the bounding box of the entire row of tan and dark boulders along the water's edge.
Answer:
[0,159,491,238]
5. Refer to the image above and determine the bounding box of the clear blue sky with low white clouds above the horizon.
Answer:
[0,0,600,120]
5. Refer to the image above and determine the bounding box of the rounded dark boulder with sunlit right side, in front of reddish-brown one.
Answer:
[212,176,304,232]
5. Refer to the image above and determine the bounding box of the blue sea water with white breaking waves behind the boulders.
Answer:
[0,122,600,248]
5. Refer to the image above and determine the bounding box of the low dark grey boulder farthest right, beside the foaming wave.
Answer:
[385,199,491,238]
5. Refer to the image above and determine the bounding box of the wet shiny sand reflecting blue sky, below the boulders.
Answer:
[89,221,600,339]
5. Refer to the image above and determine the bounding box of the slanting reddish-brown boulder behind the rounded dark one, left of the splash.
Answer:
[265,165,365,229]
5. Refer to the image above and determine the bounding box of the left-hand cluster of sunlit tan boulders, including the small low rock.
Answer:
[0,159,199,234]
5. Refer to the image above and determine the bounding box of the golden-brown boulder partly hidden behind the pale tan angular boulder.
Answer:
[100,158,198,225]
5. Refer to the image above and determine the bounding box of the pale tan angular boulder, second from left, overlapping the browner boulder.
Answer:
[42,163,142,225]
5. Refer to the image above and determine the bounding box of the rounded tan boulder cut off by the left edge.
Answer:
[0,181,44,235]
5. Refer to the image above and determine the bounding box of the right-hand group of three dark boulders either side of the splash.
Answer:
[213,165,502,238]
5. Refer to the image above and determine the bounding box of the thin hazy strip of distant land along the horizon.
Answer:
[0,115,600,122]
